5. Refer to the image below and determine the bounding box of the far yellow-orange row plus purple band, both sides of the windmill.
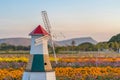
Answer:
[0,57,120,69]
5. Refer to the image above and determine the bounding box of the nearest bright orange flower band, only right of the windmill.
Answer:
[55,67,120,80]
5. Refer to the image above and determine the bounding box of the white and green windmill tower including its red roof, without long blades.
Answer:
[22,25,56,80]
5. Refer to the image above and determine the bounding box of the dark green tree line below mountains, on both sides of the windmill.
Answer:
[0,41,120,52]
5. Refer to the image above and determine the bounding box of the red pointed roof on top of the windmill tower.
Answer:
[30,25,48,35]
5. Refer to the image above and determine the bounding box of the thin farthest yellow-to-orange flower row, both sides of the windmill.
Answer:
[0,57,120,62]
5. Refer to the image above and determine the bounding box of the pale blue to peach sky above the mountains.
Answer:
[0,0,120,41]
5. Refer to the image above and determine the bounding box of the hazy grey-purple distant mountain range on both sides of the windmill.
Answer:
[0,37,97,46]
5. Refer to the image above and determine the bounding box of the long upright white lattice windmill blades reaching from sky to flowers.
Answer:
[41,11,57,64]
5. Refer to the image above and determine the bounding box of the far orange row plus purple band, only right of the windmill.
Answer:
[52,57,120,67]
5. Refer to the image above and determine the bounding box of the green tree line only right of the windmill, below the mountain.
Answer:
[56,42,120,52]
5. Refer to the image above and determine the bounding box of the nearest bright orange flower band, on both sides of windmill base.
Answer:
[0,67,120,80]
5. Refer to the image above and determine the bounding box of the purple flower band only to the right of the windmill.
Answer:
[51,61,120,67]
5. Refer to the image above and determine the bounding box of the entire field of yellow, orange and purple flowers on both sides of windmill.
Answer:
[0,54,120,80]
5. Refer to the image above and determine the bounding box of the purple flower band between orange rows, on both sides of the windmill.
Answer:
[0,61,120,69]
